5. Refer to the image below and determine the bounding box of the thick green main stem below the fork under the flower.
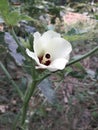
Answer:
[21,81,37,126]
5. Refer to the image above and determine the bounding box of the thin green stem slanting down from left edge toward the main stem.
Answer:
[0,61,23,100]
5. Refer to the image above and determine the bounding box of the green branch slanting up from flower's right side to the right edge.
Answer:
[67,46,98,66]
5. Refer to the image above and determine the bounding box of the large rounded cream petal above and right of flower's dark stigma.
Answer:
[45,38,72,60]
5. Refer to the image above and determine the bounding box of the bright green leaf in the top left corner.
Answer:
[0,0,33,26]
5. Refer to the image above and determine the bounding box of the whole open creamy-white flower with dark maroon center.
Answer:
[26,31,72,71]
